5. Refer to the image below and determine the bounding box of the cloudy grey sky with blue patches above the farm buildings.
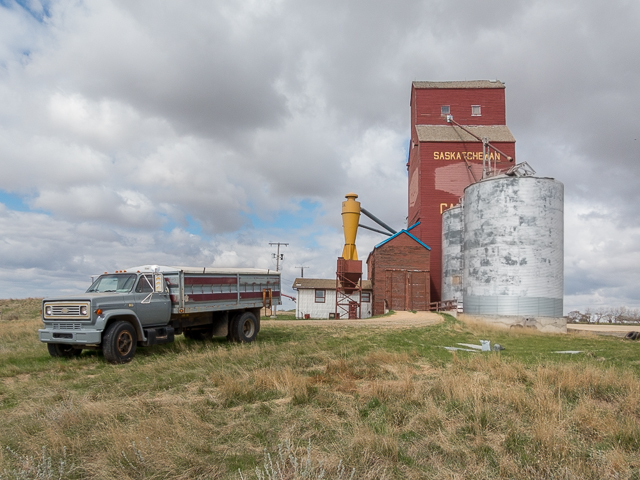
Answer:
[0,0,640,313]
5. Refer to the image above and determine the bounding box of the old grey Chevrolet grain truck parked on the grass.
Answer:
[38,265,281,363]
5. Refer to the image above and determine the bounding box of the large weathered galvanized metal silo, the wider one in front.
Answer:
[463,176,564,317]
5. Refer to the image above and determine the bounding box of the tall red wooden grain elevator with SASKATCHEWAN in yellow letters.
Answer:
[407,80,516,302]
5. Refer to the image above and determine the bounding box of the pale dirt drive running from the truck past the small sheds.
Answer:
[260,312,443,328]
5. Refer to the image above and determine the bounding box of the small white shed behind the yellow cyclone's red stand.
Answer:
[292,278,373,318]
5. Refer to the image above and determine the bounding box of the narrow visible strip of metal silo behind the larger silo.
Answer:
[442,205,464,304]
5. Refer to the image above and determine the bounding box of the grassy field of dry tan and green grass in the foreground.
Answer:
[0,299,640,479]
